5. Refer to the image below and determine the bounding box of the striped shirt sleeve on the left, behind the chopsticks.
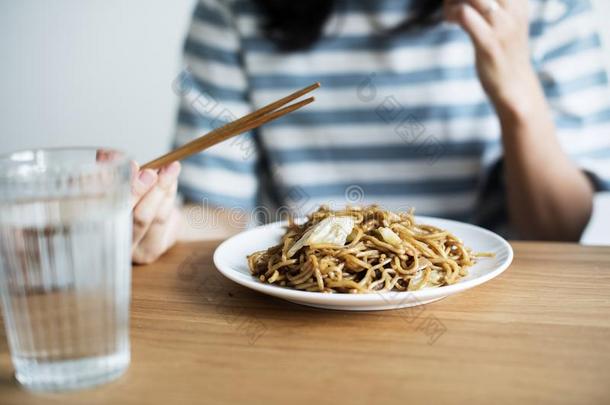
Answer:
[173,0,259,210]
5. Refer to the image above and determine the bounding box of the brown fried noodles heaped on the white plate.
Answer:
[248,205,489,293]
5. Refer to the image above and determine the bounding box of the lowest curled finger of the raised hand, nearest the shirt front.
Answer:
[447,4,496,54]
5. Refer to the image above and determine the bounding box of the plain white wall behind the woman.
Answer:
[0,0,610,242]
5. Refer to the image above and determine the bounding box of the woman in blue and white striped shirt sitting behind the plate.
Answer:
[129,0,610,262]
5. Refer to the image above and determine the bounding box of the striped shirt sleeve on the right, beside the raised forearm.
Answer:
[531,0,610,191]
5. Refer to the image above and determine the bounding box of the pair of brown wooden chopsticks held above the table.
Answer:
[142,83,320,169]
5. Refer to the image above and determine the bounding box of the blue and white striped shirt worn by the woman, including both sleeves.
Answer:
[175,0,610,229]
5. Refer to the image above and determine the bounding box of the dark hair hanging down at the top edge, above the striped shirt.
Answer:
[253,0,443,52]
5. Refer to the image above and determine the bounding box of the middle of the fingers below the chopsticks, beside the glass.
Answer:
[133,162,180,247]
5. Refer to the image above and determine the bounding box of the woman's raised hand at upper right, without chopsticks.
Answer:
[444,0,540,115]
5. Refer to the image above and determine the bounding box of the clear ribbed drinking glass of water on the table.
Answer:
[0,148,131,391]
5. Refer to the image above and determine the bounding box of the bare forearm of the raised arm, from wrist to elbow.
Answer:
[497,80,594,241]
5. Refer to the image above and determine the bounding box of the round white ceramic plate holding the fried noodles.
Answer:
[214,217,513,311]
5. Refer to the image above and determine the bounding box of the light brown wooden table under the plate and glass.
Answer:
[0,243,610,405]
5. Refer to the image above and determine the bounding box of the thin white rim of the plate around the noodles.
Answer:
[212,215,514,304]
